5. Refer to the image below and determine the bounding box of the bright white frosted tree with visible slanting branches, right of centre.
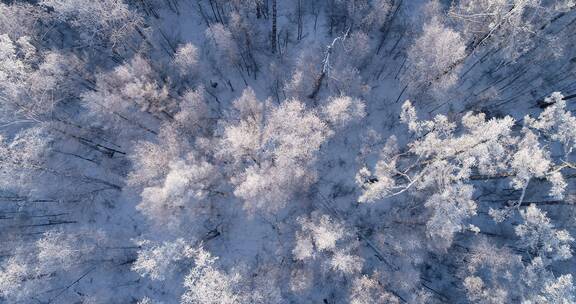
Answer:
[357,102,513,245]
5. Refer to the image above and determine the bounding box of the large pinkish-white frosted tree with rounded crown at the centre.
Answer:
[221,89,332,211]
